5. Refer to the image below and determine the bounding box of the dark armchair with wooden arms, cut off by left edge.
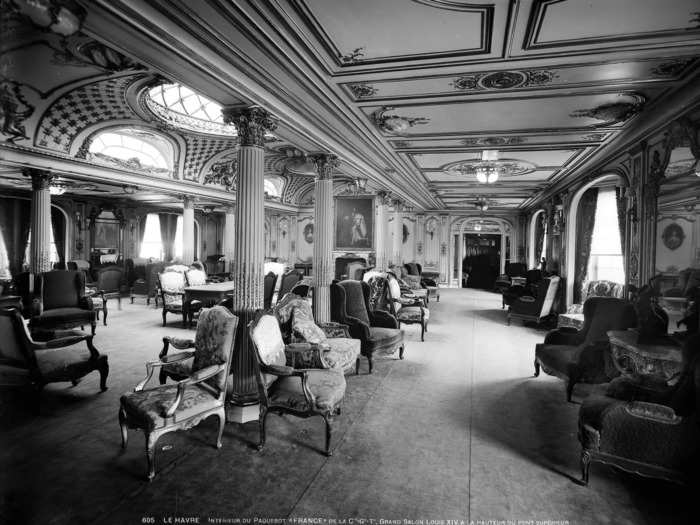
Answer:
[0,308,109,399]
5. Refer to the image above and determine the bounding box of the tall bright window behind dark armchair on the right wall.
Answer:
[588,188,625,283]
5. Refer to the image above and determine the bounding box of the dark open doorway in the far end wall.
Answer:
[462,233,501,290]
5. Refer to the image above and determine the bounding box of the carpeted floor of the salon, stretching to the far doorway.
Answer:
[0,290,697,525]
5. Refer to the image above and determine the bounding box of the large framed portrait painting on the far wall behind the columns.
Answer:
[335,197,374,251]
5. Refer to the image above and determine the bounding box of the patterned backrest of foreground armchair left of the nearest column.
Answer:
[192,306,238,392]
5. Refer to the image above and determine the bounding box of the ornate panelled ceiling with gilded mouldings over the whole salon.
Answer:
[0,0,700,212]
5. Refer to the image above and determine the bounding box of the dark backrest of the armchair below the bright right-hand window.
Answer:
[581,297,637,343]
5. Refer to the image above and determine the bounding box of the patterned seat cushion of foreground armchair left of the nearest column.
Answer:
[121,384,221,430]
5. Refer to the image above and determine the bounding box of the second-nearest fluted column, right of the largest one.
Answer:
[313,155,339,322]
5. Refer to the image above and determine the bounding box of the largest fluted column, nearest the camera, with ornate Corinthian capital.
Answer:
[224,107,276,423]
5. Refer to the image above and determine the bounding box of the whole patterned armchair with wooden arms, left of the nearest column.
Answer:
[119,306,238,481]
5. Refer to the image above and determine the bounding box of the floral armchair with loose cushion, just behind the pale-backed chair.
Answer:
[273,292,361,374]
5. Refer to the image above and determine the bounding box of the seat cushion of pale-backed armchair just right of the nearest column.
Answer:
[268,368,346,411]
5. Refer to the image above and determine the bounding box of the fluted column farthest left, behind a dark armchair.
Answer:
[24,168,54,273]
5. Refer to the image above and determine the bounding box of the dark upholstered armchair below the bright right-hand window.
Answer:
[535,297,637,401]
